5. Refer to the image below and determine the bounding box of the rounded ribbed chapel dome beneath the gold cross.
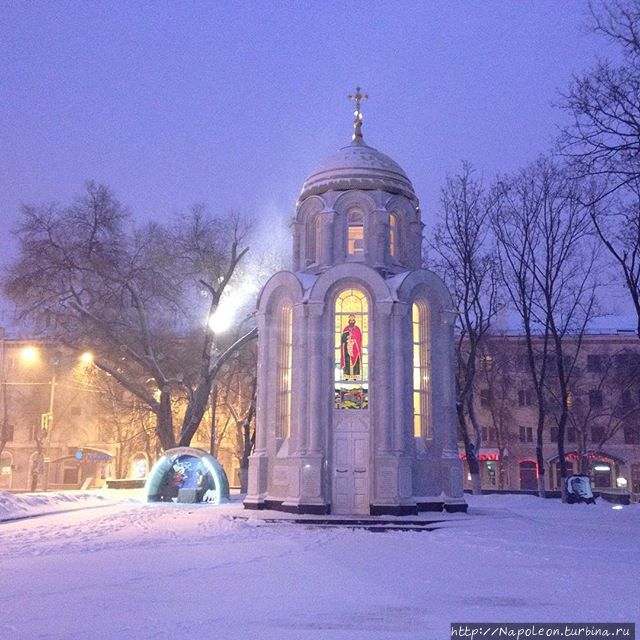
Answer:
[299,138,417,202]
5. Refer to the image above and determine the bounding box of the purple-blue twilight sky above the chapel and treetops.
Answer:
[0,0,628,322]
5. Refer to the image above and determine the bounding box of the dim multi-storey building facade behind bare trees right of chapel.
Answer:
[459,331,640,500]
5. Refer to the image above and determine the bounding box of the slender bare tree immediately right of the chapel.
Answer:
[430,163,498,493]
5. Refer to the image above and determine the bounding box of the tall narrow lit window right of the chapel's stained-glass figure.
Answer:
[411,301,432,439]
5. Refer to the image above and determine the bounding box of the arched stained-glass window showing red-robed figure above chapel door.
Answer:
[334,289,369,409]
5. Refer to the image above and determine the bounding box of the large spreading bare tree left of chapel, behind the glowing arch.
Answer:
[3,183,255,449]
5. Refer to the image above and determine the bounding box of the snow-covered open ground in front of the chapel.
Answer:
[0,492,640,640]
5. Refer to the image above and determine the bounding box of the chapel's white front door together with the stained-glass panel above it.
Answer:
[331,288,370,515]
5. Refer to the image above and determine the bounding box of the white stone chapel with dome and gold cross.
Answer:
[244,88,467,516]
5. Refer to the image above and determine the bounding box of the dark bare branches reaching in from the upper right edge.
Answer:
[559,0,640,337]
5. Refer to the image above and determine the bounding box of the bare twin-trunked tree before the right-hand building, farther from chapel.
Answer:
[493,158,597,495]
